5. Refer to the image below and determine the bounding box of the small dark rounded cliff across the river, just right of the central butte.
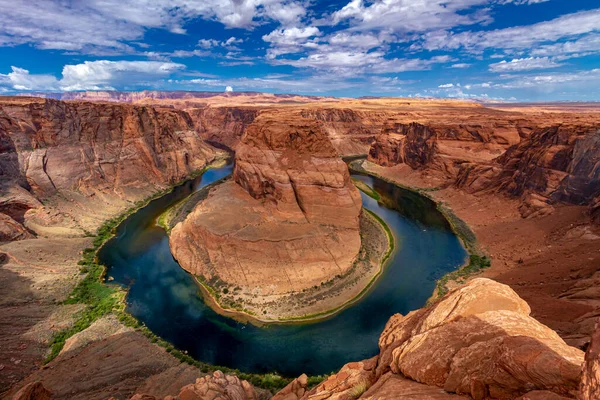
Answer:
[368,123,437,169]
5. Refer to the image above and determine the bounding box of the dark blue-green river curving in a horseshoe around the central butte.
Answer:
[98,159,467,377]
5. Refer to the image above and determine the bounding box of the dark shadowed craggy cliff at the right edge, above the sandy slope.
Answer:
[456,124,600,216]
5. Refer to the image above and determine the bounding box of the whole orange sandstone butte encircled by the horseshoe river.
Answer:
[170,114,362,315]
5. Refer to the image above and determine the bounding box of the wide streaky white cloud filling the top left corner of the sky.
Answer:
[0,0,306,55]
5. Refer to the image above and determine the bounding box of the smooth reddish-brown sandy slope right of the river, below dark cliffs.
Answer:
[360,163,600,348]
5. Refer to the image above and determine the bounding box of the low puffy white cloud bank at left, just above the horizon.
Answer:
[0,60,185,91]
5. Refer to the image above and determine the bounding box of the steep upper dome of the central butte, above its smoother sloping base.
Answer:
[233,116,362,229]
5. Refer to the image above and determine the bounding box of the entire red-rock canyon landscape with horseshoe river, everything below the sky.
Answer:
[0,92,600,400]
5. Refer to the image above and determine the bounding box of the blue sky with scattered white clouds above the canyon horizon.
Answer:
[0,0,600,101]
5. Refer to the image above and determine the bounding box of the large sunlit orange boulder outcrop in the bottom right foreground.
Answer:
[282,278,583,400]
